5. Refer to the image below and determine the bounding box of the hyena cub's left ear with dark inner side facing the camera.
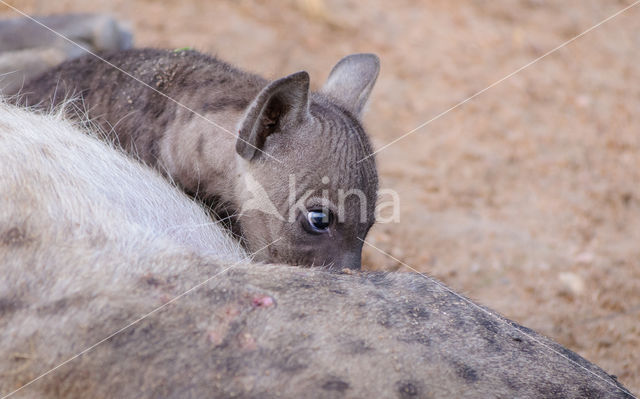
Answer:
[236,71,309,161]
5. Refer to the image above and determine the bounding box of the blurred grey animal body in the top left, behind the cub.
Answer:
[0,14,132,95]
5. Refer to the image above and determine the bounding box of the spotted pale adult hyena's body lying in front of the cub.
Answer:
[0,105,629,398]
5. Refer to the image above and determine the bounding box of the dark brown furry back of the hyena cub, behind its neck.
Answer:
[21,49,267,165]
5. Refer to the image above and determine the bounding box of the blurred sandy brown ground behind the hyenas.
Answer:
[0,0,640,393]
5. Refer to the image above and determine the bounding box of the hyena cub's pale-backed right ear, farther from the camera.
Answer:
[320,54,380,117]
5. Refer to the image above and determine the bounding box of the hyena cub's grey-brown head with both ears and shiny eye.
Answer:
[236,54,380,269]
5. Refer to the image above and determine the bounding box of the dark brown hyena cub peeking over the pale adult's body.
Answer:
[22,49,379,269]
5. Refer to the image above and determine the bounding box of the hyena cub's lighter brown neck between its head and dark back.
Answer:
[157,59,269,213]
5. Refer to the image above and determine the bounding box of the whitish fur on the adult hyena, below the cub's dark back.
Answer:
[0,104,244,260]
